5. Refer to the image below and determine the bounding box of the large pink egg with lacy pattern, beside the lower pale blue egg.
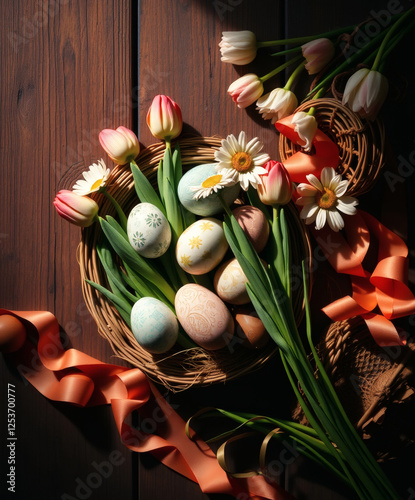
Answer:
[175,283,234,350]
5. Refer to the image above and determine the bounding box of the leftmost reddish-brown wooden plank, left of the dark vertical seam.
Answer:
[0,0,133,500]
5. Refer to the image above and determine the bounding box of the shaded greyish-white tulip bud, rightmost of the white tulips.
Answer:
[343,68,389,120]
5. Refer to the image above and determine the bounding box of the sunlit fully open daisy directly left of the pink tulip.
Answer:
[215,131,270,191]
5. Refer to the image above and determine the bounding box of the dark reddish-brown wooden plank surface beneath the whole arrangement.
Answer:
[0,0,415,500]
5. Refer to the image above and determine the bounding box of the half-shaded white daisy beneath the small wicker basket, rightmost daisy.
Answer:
[297,167,358,232]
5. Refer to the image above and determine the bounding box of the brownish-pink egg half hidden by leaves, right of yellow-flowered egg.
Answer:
[232,205,269,252]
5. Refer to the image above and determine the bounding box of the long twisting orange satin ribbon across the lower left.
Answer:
[0,309,292,500]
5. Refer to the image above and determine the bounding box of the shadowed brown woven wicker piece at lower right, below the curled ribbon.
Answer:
[294,317,415,461]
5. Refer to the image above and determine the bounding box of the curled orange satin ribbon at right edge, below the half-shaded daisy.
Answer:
[312,210,415,346]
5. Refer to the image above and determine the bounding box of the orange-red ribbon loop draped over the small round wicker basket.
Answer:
[275,115,339,182]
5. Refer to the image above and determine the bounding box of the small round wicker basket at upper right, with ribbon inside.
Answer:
[279,98,385,196]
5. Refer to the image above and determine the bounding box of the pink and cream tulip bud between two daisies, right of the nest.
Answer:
[257,160,293,205]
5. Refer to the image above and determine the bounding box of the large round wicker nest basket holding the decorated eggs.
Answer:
[78,137,311,391]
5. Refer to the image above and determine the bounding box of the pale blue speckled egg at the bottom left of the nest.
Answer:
[131,297,179,354]
